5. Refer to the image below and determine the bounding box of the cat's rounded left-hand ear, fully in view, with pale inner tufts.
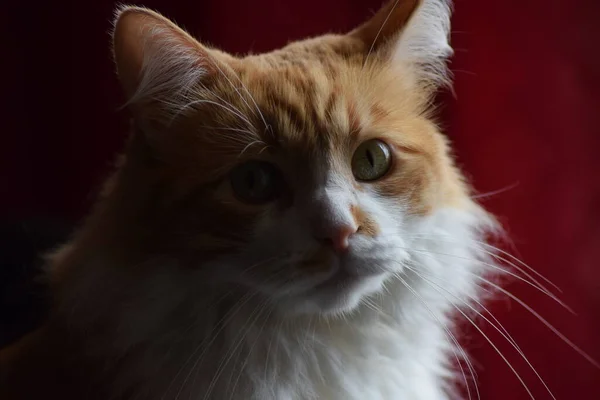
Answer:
[113,7,218,114]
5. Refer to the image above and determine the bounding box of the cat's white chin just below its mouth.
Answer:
[280,272,389,316]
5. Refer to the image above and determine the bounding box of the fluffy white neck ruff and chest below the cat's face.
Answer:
[48,208,490,400]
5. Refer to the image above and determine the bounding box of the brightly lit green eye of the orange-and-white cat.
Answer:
[352,139,392,181]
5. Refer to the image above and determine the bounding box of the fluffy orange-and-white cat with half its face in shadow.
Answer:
[0,0,497,400]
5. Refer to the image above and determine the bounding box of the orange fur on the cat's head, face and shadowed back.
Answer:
[0,0,470,400]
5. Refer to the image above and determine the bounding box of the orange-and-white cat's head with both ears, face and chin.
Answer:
[108,0,470,314]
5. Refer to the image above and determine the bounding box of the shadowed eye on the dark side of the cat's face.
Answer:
[229,161,282,204]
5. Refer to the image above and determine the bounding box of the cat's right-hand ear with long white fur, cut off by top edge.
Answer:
[349,0,453,89]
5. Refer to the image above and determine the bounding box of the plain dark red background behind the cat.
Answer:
[0,0,600,400]
